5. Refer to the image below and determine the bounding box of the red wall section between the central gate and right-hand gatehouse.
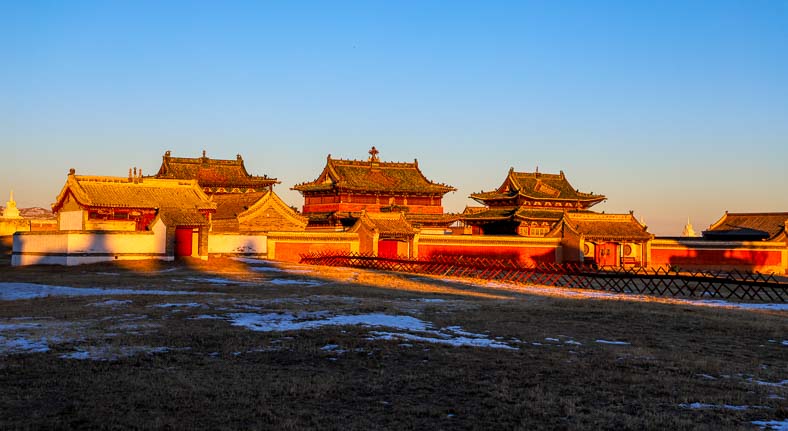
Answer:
[419,244,556,264]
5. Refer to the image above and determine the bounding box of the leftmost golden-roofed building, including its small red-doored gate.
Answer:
[52,169,216,256]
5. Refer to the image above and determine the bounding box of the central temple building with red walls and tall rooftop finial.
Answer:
[292,147,457,230]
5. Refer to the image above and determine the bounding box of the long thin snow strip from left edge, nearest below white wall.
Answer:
[0,283,217,301]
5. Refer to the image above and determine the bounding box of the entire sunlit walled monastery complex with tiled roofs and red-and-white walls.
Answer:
[6,147,788,274]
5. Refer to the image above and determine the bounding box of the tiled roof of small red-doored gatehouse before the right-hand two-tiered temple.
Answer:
[563,212,653,241]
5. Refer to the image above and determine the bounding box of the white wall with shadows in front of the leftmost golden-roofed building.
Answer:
[11,221,173,266]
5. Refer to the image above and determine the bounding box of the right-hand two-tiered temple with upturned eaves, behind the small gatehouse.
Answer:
[461,168,606,237]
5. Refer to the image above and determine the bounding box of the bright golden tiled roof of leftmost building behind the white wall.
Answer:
[52,170,216,212]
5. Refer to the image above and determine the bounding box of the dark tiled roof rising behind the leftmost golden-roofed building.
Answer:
[155,151,280,192]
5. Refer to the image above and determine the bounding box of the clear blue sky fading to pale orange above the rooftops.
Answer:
[0,0,788,235]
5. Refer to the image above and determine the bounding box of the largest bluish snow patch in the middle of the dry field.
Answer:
[196,311,517,350]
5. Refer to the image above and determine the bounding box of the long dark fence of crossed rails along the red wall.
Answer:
[301,252,788,302]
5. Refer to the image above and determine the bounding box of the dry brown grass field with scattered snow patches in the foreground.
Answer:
[0,259,788,430]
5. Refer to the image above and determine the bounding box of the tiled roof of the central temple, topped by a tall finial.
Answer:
[292,147,457,195]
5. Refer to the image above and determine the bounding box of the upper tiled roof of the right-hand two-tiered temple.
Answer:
[470,168,605,205]
